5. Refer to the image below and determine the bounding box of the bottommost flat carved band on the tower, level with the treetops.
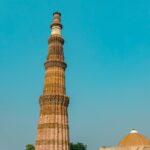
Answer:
[36,140,68,145]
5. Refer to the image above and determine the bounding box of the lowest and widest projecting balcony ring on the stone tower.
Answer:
[40,95,69,106]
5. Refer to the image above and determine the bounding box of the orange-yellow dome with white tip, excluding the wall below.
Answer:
[119,130,150,147]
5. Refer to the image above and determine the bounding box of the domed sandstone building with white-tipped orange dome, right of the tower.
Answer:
[100,129,150,150]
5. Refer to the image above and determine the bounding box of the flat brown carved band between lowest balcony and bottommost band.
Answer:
[38,123,69,129]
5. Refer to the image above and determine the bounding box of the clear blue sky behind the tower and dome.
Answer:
[0,0,150,150]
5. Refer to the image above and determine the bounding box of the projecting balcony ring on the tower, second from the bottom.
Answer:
[44,61,67,69]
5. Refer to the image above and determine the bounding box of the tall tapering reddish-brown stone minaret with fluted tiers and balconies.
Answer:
[35,12,69,150]
